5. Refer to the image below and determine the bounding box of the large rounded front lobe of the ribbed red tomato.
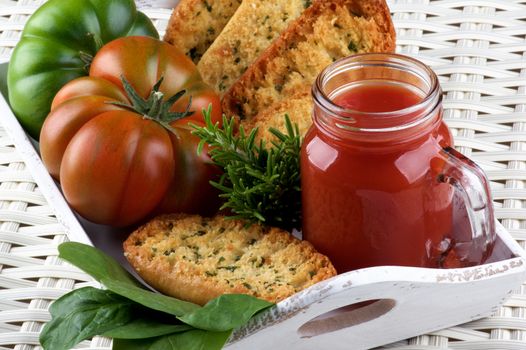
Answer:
[60,111,175,226]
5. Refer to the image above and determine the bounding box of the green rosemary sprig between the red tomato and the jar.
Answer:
[192,108,301,230]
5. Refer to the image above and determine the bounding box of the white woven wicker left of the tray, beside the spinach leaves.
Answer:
[0,127,110,350]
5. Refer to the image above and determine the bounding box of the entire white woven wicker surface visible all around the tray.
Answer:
[0,0,526,350]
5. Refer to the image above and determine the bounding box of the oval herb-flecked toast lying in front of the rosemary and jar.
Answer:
[124,214,336,305]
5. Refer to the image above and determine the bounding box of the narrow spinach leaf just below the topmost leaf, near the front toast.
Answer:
[100,278,201,316]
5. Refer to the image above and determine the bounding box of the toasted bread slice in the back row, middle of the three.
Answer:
[197,0,311,93]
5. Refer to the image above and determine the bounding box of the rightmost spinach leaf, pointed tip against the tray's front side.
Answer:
[178,294,274,332]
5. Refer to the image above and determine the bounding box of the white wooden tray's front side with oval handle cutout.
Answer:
[227,252,526,350]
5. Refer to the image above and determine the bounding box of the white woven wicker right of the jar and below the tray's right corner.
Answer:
[385,0,526,350]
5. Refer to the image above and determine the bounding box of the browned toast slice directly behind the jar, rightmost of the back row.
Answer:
[223,0,395,123]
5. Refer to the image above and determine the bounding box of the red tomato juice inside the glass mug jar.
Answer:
[301,81,453,273]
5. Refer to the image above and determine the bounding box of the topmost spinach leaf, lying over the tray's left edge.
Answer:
[58,242,141,286]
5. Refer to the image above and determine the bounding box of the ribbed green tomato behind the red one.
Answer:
[7,0,159,140]
